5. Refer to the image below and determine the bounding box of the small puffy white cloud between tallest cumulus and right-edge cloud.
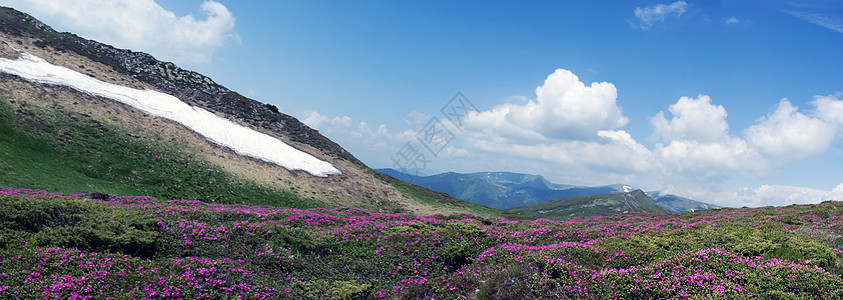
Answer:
[650,95,729,142]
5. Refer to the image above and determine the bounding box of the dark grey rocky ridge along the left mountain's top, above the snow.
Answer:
[0,7,365,167]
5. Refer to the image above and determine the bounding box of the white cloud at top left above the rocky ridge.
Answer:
[0,0,239,65]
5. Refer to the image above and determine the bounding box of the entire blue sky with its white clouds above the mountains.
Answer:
[0,0,843,206]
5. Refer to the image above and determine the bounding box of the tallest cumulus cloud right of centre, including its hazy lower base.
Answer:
[452,69,653,179]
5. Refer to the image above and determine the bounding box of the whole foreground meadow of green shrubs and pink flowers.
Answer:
[0,188,843,299]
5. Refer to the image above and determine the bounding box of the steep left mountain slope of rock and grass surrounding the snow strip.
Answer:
[0,8,508,215]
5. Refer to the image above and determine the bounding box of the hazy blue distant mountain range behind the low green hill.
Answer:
[377,169,719,213]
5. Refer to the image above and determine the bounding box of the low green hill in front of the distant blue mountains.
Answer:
[509,190,667,220]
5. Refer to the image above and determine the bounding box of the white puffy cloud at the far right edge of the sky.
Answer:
[744,99,836,161]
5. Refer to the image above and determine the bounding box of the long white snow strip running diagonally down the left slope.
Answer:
[0,53,342,177]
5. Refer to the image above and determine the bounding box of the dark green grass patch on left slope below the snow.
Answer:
[0,99,329,208]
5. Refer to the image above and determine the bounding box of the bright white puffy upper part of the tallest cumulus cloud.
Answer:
[466,69,629,142]
